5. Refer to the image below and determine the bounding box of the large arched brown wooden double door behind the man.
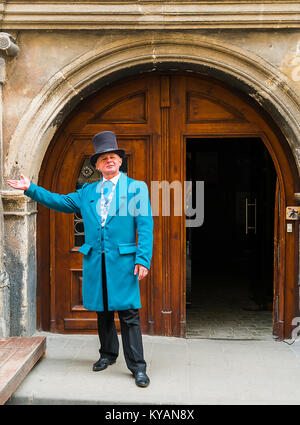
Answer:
[37,72,300,336]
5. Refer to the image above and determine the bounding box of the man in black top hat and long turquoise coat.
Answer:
[7,131,153,387]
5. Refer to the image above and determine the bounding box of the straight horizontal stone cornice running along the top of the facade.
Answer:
[0,0,300,30]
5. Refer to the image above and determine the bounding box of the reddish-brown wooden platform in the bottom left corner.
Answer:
[0,336,46,405]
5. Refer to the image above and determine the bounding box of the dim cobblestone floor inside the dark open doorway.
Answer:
[186,274,273,340]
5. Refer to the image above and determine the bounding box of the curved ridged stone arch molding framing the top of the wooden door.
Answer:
[5,34,300,180]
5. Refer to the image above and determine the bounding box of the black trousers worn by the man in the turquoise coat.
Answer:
[97,254,147,373]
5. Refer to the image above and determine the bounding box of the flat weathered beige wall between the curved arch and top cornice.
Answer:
[3,29,300,153]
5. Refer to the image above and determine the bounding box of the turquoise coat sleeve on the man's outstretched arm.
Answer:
[24,182,85,213]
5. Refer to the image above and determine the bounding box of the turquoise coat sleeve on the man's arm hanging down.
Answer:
[135,182,153,269]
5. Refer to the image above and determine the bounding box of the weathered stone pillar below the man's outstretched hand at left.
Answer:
[0,190,37,336]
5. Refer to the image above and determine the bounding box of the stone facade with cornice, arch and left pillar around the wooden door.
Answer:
[0,1,300,337]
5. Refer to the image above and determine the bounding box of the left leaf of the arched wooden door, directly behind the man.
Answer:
[39,78,161,333]
